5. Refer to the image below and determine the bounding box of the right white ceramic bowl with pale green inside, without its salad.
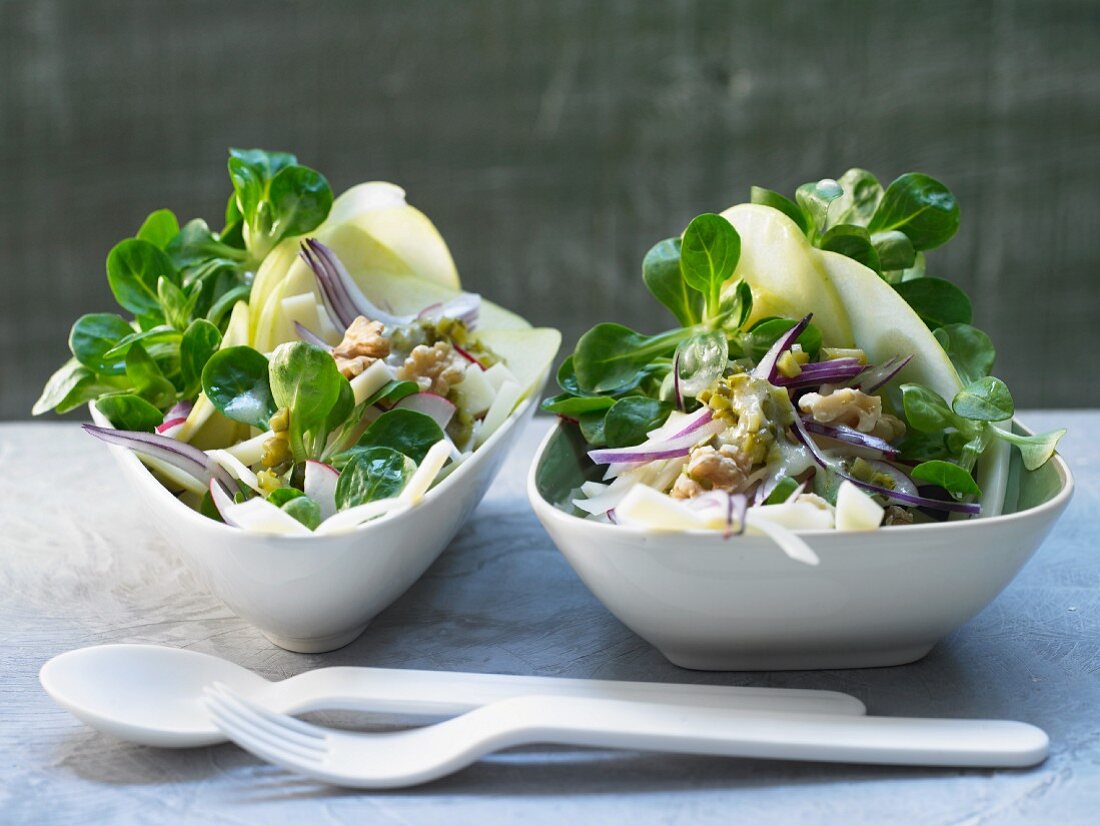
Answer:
[528,425,1074,671]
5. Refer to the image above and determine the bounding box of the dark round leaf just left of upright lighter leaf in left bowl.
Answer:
[202,345,279,430]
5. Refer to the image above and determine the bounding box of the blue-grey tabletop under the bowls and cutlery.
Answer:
[0,411,1100,824]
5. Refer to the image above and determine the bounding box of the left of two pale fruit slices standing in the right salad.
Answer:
[722,203,858,348]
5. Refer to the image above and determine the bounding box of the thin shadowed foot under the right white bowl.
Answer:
[661,643,935,671]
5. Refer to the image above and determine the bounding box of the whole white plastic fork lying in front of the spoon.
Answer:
[205,684,1048,789]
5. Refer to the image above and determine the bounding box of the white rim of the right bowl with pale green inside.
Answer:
[527,417,1075,540]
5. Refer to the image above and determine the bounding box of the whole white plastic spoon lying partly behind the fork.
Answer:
[39,645,867,748]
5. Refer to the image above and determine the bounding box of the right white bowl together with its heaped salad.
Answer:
[529,169,1071,668]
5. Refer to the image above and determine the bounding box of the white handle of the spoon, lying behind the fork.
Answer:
[265,668,867,716]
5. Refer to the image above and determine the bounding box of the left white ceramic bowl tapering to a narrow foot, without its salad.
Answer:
[92,395,537,653]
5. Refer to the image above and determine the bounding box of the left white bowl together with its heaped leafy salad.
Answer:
[34,150,560,650]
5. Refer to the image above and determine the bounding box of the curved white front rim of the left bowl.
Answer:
[88,391,545,546]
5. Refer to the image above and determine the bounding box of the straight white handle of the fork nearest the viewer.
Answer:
[481,697,1049,768]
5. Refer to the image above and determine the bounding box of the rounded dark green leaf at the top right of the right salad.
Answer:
[868,172,959,250]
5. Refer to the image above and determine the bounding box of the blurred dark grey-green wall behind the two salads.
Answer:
[0,0,1100,419]
